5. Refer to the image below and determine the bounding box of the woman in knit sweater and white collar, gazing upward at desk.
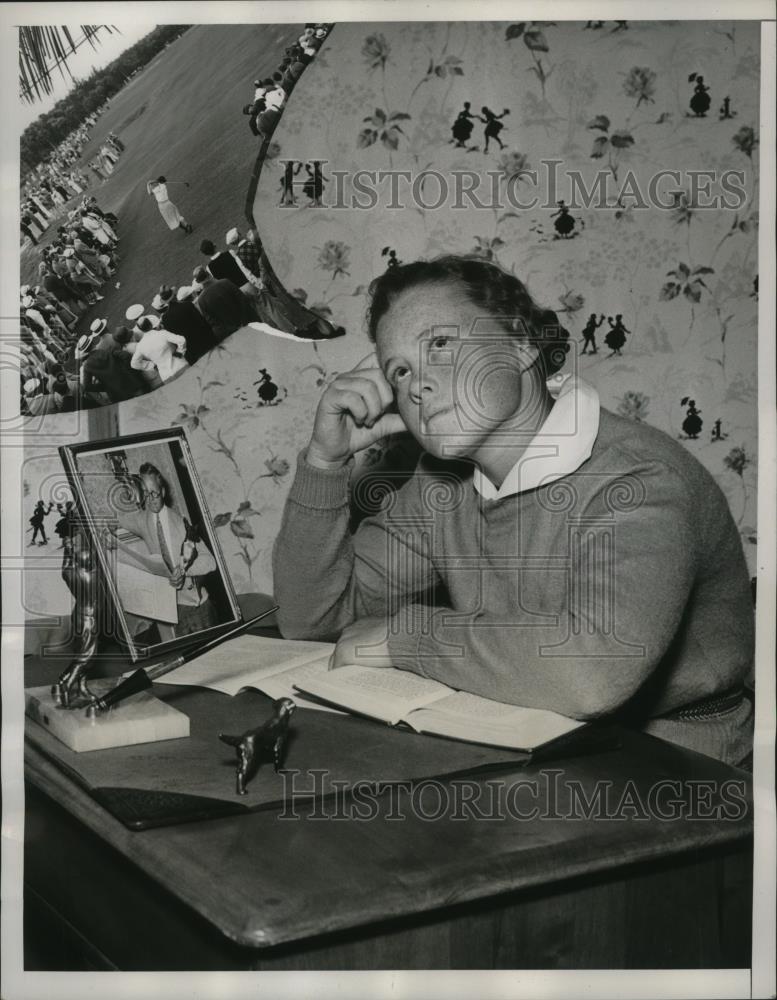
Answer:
[274,257,753,764]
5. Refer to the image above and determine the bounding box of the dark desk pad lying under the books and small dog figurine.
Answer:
[26,684,615,829]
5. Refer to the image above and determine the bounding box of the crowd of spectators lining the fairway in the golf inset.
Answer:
[21,24,344,415]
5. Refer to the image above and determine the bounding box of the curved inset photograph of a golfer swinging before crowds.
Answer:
[19,24,344,416]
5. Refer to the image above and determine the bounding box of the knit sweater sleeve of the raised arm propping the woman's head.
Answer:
[273,451,438,641]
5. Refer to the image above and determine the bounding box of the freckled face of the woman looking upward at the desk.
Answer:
[376,283,531,460]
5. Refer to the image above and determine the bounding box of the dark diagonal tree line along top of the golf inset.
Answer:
[20,24,191,179]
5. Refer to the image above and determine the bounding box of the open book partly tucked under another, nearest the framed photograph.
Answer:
[162,635,343,715]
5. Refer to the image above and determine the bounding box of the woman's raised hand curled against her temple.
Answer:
[306,354,407,469]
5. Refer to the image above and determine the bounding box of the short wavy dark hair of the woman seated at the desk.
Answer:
[367,254,569,378]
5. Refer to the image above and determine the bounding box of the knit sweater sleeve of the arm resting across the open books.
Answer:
[389,463,699,719]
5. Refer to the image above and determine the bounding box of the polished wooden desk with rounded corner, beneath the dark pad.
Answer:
[25,652,752,971]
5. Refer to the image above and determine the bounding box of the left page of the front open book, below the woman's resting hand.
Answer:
[298,666,451,725]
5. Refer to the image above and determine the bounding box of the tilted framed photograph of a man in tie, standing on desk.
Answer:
[59,427,242,662]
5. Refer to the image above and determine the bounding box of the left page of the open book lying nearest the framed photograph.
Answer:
[164,635,335,695]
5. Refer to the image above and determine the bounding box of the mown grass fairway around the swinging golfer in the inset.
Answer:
[21,24,302,333]
